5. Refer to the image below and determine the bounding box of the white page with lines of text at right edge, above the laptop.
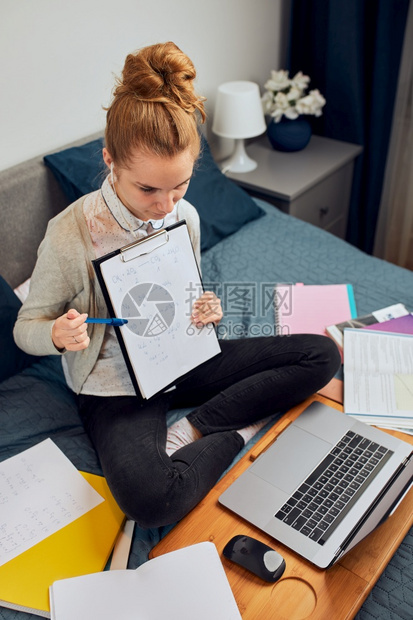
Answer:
[344,329,413,427]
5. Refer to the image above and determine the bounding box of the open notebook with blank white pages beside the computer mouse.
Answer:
[50,542,241,620]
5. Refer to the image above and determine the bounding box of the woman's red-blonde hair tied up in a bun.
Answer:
[105,42,206,167]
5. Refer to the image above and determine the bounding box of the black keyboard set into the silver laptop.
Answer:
[275,431,393,545]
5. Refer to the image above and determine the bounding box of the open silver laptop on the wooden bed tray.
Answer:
[219,402,413,568]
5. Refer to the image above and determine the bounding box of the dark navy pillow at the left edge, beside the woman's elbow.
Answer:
[0,276,38,382]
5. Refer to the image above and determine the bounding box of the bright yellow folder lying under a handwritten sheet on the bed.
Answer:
[0,472,125,617]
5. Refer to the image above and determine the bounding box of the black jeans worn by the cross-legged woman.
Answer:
[80,334,340,528]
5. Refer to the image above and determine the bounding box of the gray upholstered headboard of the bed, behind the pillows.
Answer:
[0,133,102,288]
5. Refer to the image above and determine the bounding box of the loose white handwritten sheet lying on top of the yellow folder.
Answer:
[0,439,103,566]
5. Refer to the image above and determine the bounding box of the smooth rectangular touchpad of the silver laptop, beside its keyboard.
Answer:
[249,426,332,494]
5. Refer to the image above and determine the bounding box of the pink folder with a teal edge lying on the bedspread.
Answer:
[275,283,357,335]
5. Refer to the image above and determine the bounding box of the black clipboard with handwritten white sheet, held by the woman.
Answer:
[92,220,221,399]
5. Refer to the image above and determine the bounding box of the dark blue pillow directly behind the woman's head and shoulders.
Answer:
[44,136,264,250]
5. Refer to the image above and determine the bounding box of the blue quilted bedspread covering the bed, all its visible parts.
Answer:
[0,201,413,620]
